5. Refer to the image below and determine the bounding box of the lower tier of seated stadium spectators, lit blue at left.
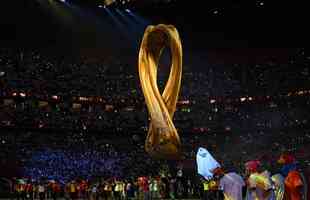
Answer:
[0,126,310,182]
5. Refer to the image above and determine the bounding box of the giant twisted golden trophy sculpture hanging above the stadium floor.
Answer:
[139,24,182,159]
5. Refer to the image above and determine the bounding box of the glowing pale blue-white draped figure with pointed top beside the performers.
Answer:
[196,147,221,180]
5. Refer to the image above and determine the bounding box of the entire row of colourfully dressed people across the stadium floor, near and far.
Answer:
[6,153,310,200]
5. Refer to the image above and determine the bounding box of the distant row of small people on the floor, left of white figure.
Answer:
[8,173,202,200]
